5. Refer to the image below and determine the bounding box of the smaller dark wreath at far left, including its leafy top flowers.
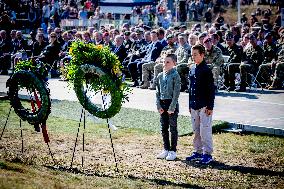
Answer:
[7,60,51,125]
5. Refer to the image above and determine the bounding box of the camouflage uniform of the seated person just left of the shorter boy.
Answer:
[141,45,176,88]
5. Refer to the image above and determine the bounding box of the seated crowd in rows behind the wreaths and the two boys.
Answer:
[0,10,284,91]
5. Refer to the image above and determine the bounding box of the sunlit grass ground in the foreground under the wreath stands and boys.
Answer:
[0,100,284,188]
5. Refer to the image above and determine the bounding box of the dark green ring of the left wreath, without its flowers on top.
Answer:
[7,70,51,125]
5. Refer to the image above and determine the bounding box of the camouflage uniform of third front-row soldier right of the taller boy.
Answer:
[240,45,264,90]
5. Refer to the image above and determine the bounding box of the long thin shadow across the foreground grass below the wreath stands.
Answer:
[45,166,202,188]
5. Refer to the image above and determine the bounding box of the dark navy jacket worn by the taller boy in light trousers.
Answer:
[188,60,215,110]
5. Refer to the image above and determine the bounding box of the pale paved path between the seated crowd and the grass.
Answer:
[0,76,284,130]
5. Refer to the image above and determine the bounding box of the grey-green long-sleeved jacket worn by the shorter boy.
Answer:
[155,68,181,111]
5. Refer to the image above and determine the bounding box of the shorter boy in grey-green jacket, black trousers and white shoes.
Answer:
[156,54,180,161]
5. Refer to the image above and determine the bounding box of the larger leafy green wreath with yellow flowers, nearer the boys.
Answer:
[66,42,130,119]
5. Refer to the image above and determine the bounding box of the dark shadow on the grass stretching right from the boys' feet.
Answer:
[181,160,283,176]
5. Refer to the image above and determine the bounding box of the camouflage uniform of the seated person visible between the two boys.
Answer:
[175,43,191,91]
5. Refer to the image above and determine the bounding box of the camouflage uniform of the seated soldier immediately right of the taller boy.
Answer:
[204,45,224,86]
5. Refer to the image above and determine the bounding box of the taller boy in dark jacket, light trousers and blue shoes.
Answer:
[186,44,215,164]
